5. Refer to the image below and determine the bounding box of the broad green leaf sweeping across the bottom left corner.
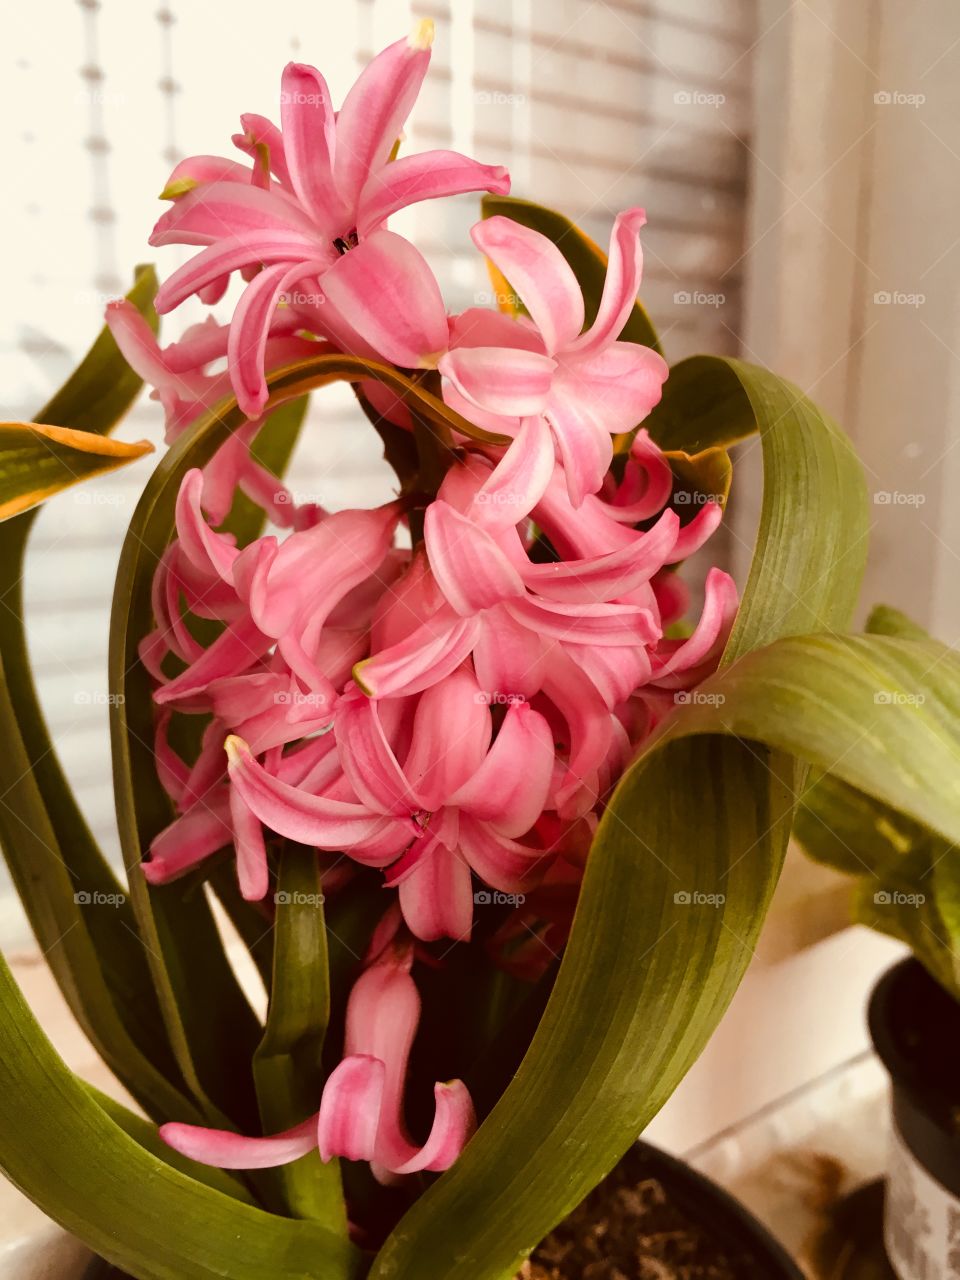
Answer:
[0,960,360,1280]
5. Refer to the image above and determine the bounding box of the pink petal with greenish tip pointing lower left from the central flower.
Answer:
[353,607,479,698]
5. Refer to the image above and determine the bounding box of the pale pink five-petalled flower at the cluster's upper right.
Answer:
[439,209,668,507]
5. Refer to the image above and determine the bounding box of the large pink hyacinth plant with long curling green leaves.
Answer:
[0,23,960,1280]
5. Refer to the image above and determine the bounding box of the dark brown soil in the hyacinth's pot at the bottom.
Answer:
[517,1151,776,1280]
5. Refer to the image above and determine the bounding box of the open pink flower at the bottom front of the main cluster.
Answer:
[228,666,554,941]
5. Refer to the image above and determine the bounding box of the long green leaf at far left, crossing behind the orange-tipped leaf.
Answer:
[0,268,198,1119]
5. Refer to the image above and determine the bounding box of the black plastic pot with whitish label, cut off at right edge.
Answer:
[868,959,960,1280]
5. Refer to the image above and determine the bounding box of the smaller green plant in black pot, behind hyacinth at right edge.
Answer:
[796,605,960,1280]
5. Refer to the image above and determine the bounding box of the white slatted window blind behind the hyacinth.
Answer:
[0,0,755,926]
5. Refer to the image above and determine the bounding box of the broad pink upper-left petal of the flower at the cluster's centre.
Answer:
[424,498,524,617]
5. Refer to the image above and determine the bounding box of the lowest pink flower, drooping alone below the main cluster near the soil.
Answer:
[160,948,476,1181]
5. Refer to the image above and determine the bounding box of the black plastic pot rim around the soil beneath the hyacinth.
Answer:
[534,1142,803,1280]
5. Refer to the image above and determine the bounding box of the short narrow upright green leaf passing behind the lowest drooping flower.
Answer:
[253,845,347,1236]
